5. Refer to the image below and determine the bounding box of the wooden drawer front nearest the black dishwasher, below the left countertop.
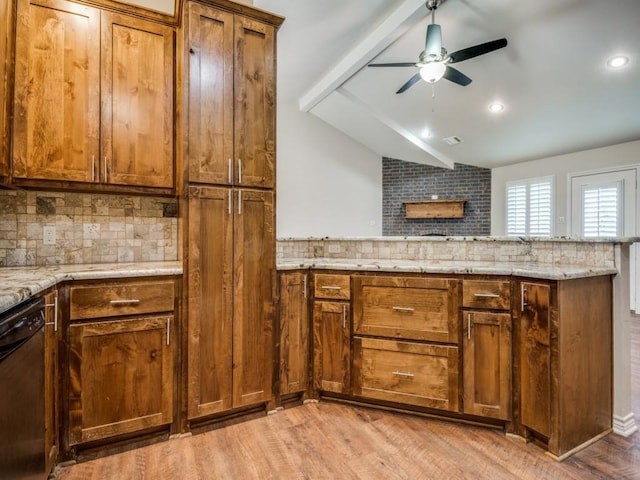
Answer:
[69,281,175,320]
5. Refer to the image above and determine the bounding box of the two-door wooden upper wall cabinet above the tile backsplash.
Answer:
[13,0,175,192]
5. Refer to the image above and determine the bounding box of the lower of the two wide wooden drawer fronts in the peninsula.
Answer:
[354,337,458,412]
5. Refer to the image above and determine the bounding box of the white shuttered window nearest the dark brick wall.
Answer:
[507,177,553,237]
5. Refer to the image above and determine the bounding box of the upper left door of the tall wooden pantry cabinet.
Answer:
[185,2,235,184]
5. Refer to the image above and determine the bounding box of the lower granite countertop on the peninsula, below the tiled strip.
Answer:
[276,258,618,280]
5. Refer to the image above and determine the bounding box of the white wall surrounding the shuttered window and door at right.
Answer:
[491,141,640,235]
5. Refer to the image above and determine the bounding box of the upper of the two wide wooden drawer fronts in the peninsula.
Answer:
[354,277,458,344]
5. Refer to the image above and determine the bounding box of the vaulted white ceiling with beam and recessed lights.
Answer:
[254,0,640,168]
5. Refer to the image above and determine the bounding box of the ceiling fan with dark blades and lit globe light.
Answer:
[369,0,507,93]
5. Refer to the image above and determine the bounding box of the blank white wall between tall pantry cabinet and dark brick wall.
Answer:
[276,103,382,238]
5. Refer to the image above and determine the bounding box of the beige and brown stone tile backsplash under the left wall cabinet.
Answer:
[0,191,178,267]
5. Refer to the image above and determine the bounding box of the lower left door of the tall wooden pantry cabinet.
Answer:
[187,187,233,418]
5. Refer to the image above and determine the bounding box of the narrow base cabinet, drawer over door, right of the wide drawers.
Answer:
[462,279,512,420]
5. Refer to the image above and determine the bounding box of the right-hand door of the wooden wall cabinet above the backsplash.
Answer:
[99,12,174,188]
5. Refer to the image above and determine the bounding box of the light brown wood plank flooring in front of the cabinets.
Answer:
[54,316,640,480]
